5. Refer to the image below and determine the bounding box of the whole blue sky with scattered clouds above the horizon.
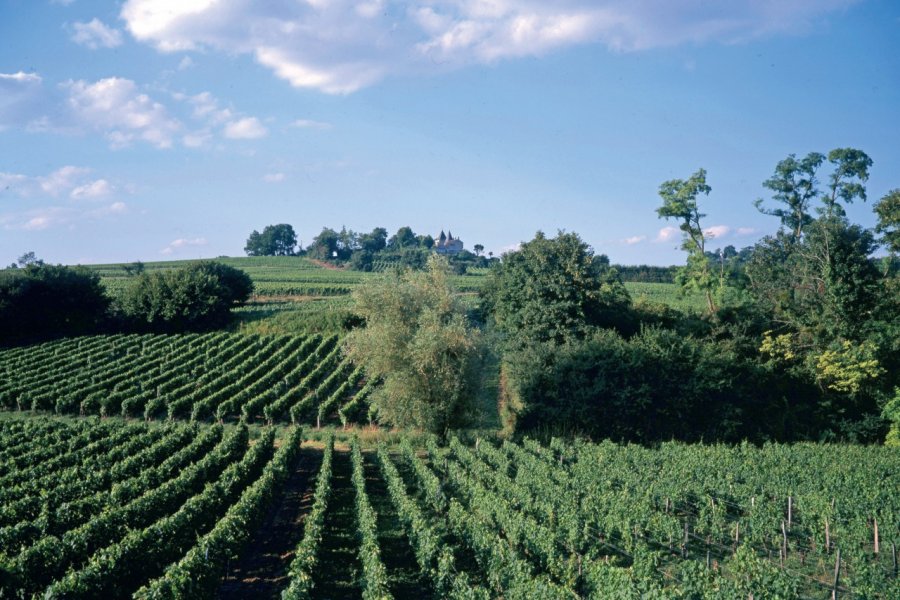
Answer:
[0,0,900,265]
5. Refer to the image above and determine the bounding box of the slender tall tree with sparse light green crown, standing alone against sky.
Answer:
[656,169,716,314]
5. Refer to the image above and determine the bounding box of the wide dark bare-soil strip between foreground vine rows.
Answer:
[218,448,322,600]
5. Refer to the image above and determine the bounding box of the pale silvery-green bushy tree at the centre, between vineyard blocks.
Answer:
[347,256,481,434]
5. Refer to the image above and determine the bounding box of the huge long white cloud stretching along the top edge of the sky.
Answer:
[121,0,858,94]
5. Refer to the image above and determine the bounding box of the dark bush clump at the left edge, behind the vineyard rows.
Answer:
[0,262,110,344]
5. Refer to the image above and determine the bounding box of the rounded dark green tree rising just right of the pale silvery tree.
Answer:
[484,231,631,347]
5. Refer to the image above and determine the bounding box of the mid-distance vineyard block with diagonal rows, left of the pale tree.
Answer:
[0,332,374,425]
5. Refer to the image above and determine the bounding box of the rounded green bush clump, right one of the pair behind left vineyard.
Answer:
[119,262,253,332]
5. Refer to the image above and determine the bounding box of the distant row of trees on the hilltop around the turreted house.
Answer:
[244,223,495,274]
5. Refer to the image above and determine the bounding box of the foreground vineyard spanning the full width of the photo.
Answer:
[0,414,900,600]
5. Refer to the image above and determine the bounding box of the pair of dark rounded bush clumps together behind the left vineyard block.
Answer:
[0,257,253,344]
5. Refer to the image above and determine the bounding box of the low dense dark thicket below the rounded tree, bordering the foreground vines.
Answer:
[507,328,809,443]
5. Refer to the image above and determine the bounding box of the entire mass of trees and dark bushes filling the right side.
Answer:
[483,149,900,443]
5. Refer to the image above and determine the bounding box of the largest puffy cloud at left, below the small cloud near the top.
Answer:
[62,77,181,148]
